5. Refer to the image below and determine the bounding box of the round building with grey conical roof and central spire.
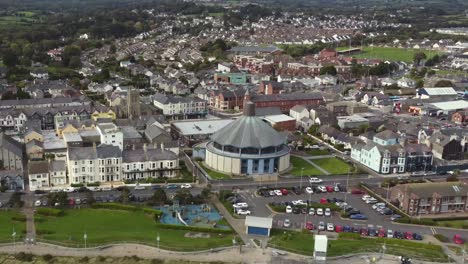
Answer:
[205,102,290,175]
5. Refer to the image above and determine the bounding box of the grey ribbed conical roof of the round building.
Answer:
[211,116,286,148]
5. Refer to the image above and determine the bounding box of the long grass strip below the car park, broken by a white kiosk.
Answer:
[269,230,447,262]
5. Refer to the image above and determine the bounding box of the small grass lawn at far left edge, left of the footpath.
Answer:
[0,210,26,242]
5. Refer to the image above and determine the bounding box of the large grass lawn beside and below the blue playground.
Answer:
[36,209,233,251]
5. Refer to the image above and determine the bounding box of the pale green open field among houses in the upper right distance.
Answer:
[337,47,440,62]
